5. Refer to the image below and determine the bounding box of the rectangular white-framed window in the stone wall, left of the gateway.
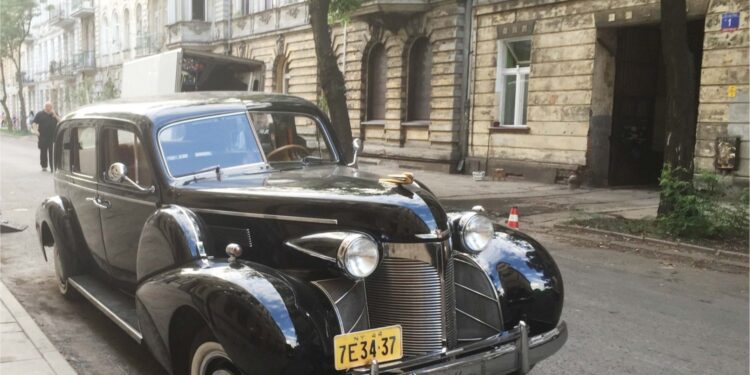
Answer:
[495,37,531,126]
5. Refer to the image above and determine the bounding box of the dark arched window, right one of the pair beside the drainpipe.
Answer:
[406,37,432,121]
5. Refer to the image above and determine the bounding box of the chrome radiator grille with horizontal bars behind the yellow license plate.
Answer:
[365,257,445,356]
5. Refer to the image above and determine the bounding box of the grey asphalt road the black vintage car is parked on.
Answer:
[0,134,750,375]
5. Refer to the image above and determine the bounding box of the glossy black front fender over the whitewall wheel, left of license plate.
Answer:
[136,259,338,374]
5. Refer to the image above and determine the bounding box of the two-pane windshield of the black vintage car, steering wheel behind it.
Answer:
[158,112,335,177]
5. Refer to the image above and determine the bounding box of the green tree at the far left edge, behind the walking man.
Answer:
[0,0,36,131]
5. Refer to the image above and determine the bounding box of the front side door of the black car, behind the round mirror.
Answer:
[99,121,158,284]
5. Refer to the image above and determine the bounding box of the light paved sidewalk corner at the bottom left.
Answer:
[0,281,76,375]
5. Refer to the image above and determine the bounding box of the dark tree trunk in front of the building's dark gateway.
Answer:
[658,0,698,216]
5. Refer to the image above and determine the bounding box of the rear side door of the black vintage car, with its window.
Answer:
[64,120,107,269]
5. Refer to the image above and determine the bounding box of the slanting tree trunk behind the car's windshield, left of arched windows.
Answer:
[309,0,352,161]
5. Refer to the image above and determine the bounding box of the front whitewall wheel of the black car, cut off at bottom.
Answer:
[190,328,242,375]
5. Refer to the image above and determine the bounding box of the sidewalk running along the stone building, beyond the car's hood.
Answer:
[360,162,659,227]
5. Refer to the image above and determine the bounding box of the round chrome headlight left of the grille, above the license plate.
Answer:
[338,233,380,279]
